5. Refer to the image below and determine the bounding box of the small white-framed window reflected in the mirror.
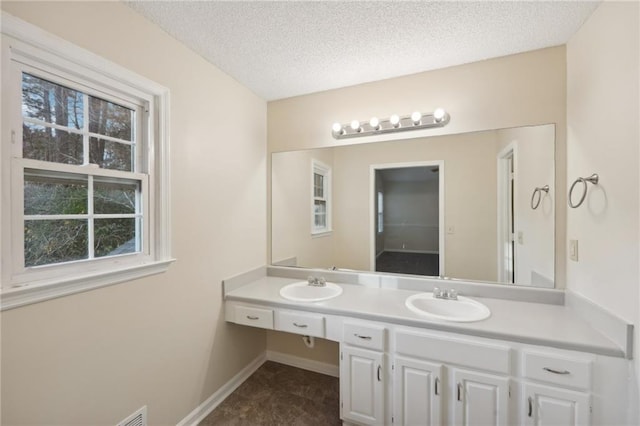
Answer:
[311,160,331,234]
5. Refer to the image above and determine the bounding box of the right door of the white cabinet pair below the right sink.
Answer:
[451,369,509,426]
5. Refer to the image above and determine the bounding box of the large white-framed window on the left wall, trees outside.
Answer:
[0,15,172,309]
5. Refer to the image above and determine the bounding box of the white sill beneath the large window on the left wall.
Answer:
[0,259,175,311]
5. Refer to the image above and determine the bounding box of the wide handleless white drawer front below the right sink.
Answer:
[395,330,511,374]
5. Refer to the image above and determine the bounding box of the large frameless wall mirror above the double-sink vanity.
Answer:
[271,124,555,288]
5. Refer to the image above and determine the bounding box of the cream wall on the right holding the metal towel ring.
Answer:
[567,2,640,424]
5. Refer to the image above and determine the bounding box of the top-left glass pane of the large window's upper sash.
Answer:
[22,73,84,129]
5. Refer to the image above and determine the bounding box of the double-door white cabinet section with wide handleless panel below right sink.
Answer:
[393,328,511,426]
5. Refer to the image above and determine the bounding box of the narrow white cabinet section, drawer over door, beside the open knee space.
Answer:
[340,322,389,425]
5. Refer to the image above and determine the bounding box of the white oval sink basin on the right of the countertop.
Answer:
[405,293,491,322]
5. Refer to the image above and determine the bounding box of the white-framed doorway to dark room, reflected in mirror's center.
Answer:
[371,160,444,276]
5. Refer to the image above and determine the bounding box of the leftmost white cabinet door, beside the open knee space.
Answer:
[340,345,385,425]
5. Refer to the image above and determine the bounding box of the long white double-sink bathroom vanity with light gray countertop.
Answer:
[225,272,630,425]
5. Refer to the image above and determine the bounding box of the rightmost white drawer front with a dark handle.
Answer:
[522,351,592,390]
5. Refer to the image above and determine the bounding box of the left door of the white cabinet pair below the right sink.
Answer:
[393,356,444,426]
